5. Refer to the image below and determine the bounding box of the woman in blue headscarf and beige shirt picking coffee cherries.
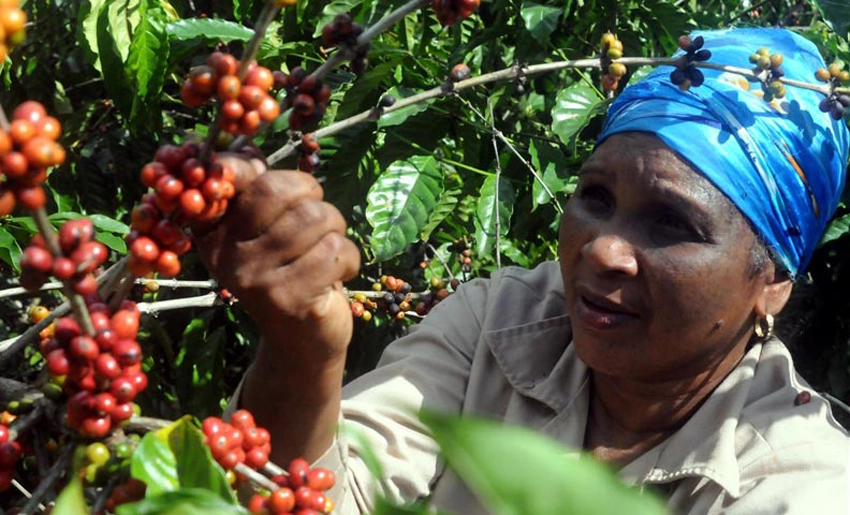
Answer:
[199,30,850,513]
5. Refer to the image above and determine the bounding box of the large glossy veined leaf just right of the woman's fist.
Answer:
[366,156,443,261]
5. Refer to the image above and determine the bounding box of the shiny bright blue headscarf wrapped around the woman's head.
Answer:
[598,29,850,276]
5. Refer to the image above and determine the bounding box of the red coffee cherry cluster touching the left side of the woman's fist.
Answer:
[127,143,236,277]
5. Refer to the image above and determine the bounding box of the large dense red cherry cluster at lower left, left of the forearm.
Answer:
[40,300,148,438]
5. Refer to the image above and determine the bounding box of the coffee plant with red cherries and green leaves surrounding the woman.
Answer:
[0,0,850,514]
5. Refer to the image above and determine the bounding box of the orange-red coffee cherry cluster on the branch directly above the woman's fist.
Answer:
[180,52,280,136]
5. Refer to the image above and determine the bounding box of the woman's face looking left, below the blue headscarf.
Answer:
[559,133,766,381]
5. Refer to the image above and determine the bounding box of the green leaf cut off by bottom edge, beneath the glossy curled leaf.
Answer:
[114,488,248,515]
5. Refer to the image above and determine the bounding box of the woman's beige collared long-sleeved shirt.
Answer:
[250,262,850,515]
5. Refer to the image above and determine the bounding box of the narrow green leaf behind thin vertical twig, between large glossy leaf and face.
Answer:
[475,175,516,256]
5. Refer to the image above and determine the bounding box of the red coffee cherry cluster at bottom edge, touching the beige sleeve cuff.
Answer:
[248,458,336,515]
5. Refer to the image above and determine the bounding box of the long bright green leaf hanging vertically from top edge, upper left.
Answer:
[127,0,169,134]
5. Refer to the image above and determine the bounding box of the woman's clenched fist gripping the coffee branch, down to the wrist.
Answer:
[193,157,360,359]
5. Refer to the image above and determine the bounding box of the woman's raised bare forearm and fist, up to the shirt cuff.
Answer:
[192,153,360,463]
